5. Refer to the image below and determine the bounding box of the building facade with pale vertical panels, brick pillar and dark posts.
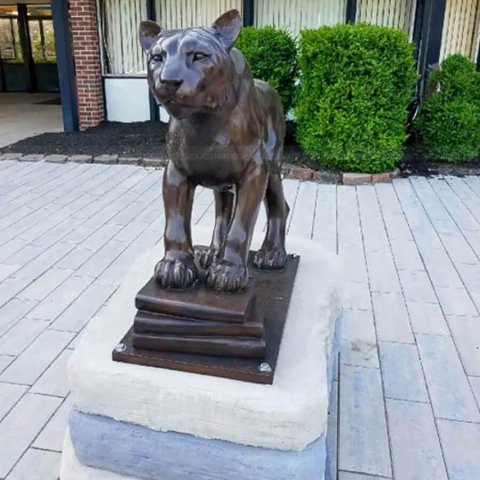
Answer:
[0,0,480,130]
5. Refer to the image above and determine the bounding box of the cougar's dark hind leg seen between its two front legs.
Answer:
[196,190,234,269]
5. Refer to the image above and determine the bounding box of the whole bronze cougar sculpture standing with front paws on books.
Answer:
[140,10,289,292]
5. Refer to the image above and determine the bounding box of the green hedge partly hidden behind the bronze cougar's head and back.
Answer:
[235,27,298,113]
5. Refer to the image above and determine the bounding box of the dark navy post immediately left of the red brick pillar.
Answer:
[52,0,78,132]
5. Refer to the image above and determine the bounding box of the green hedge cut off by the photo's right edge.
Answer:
[415,55,480,163]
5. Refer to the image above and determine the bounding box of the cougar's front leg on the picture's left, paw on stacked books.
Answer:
[154,162,198,288]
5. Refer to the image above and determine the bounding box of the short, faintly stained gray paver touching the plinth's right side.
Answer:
[340,310,380,368]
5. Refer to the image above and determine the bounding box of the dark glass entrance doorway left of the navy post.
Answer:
[0,4,59,93]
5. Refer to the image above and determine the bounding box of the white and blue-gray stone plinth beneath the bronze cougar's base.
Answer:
[61,230,342,480]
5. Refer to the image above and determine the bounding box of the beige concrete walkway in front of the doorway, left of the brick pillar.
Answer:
[0,93,63,148]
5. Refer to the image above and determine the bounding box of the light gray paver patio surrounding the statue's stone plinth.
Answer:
[0,161,480,480]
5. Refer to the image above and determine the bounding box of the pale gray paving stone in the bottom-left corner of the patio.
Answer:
[0,393,61,478]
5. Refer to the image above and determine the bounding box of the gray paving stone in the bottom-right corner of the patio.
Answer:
[438,420,480,480]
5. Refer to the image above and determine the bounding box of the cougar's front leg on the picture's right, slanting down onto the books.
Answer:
[207,154,268,292]
